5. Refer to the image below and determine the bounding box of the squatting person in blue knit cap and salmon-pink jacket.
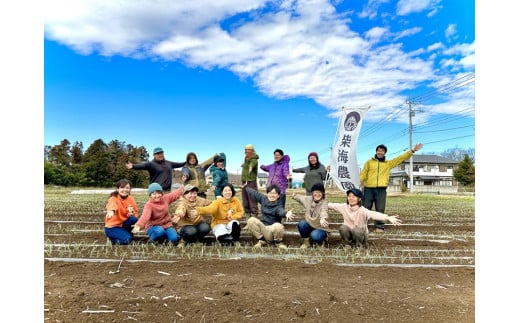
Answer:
[132,183,184,243]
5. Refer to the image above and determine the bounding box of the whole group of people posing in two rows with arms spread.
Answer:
[105,144,422,249]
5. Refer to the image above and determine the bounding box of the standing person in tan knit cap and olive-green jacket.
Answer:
[240,144,260,218]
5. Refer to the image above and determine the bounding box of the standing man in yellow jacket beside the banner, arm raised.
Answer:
[359,143,423,233]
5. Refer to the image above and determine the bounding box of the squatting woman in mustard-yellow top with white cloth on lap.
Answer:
[194,183,244,247]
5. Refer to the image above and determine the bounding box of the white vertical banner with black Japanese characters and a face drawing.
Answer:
[329,107,370,192]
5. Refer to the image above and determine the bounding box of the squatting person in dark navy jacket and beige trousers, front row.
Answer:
[244,185,294,249]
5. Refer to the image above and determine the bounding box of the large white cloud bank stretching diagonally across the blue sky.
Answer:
[45,0,474,118]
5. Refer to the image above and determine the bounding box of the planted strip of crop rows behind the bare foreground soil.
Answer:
[44,188,475,267]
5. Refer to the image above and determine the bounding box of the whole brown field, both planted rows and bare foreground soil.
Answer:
[43,188,475,322]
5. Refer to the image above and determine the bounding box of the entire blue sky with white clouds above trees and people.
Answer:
[44,0,475,177]
